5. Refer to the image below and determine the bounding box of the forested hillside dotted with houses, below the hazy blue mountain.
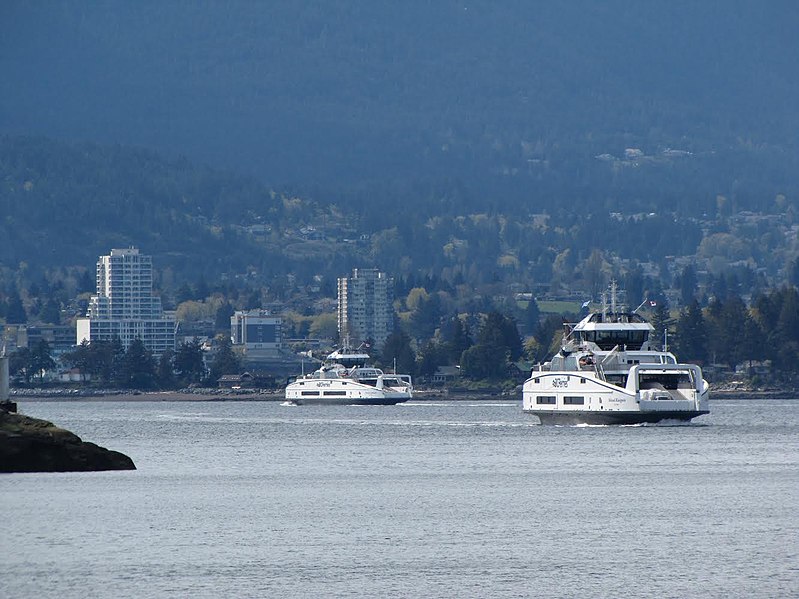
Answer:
[0,136,799,304]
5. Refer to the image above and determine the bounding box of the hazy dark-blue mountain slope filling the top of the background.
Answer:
[0,0,799,208]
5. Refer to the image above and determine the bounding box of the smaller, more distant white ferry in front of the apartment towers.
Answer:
[286,347,413,405]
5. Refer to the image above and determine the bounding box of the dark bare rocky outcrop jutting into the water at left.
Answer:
[0,410,136,472]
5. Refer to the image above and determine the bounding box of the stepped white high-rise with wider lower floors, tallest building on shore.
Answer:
[77,247,175,356]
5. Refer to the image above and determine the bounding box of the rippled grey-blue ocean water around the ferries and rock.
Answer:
[0,400,799,599]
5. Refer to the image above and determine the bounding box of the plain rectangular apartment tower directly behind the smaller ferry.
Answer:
[338,268,394,349]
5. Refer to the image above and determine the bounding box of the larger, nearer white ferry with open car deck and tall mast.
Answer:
[522,284,710,424]
